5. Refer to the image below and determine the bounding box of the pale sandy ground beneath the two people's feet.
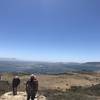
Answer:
[0,92,47,100]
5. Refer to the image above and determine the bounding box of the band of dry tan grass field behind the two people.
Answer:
[3,74,100,90]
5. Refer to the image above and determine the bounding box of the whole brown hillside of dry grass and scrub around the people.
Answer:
[0,73,100,100]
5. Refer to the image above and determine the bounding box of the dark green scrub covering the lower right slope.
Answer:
[45,84,100,100]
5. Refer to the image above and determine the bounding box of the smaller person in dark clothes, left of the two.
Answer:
[12,76,20,95]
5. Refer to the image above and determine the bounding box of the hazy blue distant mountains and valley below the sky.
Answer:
[0,58,100,74]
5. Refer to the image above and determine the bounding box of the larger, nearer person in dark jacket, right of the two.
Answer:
[26,74,38,100]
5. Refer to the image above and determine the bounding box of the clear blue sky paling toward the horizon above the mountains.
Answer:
[0,0,100,62]
